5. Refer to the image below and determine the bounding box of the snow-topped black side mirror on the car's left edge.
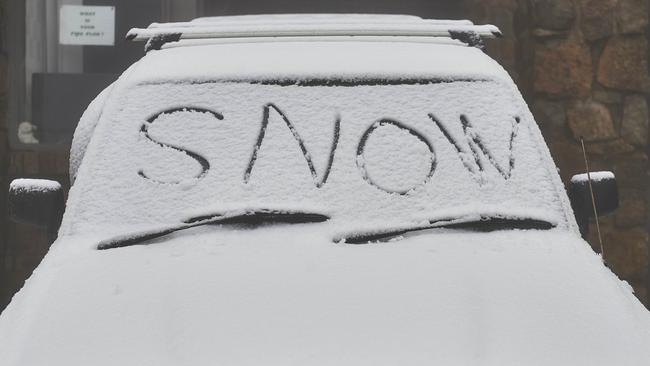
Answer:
[7,179,64,233]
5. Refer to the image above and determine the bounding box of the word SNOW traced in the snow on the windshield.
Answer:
[138,103,520,194]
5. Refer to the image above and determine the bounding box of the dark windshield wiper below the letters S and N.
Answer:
[97,209,329,250]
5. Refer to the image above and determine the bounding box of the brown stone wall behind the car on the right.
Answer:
[468,0,650,306]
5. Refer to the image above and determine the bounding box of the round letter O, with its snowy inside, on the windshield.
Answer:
[357,119,436,195]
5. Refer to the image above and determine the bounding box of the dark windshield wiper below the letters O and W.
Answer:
[334,216,556,244]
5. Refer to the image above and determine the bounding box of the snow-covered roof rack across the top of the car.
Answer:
[126,14,501,51]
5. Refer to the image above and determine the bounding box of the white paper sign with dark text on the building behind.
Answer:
[59,5,115,46]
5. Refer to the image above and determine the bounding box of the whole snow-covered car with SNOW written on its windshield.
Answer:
[0,15,650,366]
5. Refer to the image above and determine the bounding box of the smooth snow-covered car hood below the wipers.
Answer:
[0,225,650,366]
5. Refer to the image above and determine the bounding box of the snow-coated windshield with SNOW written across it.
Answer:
[65,80,566,236]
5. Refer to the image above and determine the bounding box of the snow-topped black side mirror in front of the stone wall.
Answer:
[569,172,618,238]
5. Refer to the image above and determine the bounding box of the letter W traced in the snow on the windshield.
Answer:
[429,114,519,179]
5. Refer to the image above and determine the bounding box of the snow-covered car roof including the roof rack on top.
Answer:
[120,14,510,86]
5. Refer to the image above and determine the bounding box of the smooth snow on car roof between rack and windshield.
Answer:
[129,38,511,83]
